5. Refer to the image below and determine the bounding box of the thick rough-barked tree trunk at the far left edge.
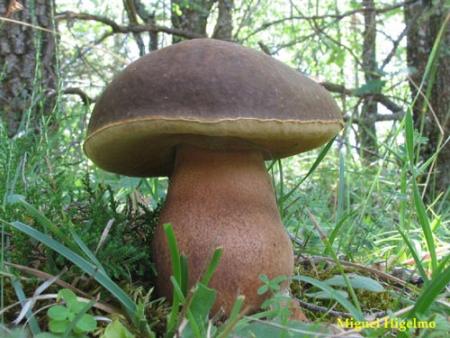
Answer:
[0,0,56,137]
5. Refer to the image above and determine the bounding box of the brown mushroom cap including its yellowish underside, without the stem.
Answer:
[84,39,342,176]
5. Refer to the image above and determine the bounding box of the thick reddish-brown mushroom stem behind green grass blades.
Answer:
[153,145,294,314]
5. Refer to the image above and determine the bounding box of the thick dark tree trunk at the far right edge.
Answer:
[404,0,450,197]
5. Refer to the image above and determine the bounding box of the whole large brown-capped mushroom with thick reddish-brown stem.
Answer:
[84,39,342,313]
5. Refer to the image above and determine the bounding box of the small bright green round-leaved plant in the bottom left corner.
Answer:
[37,289,97,338]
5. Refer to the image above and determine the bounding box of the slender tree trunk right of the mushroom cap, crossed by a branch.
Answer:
[359,0,380,163]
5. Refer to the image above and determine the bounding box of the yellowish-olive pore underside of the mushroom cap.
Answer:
[84,117,342,177]
